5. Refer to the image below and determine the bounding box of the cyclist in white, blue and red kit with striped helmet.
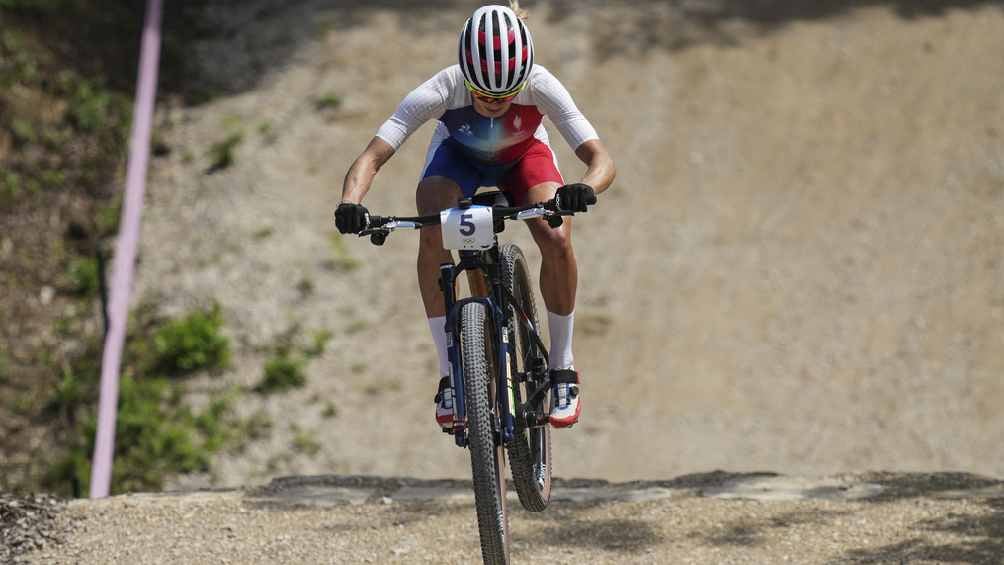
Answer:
[335,2,615,428]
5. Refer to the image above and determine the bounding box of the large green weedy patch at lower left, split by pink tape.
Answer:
[35,307,244,496]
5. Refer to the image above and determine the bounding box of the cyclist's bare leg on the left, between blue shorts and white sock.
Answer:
[415,177,463,318]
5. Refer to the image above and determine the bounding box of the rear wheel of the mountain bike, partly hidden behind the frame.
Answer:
[501,244,551,512]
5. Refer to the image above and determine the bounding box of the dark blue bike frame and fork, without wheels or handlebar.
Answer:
[440,245,547,448]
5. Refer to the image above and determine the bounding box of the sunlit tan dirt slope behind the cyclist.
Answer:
[129,1,1004,486]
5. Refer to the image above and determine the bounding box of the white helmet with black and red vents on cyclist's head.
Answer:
[459,6,533,96]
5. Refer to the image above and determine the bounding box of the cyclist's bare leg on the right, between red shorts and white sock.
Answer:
[526,183,578,316]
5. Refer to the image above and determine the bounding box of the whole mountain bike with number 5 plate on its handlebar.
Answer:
[359,191,586,564]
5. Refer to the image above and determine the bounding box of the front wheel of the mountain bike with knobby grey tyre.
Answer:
[460,302,509,564]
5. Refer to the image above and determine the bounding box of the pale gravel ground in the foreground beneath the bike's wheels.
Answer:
[19,473,1004,565]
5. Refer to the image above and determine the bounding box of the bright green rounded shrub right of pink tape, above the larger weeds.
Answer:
[146,305,230,376]
